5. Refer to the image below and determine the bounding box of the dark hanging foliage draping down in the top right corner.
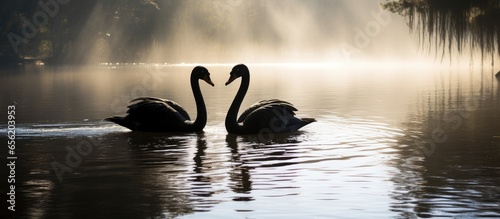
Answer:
[382,0,500,63]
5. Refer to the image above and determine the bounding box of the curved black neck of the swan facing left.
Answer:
[226,74,250,133]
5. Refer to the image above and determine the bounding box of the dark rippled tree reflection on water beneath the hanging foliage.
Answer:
[392,70,500,217]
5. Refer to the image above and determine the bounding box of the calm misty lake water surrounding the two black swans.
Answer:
[0,65,500,218]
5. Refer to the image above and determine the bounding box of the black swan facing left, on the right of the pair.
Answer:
[225,64,316,134]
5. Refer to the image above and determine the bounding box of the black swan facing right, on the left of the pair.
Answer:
[104,66,214,132]
